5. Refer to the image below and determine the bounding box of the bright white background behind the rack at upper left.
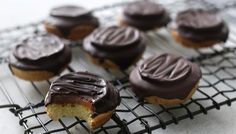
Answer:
[0,0,129,29]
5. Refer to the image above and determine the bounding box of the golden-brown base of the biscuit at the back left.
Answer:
[44,23,96,40]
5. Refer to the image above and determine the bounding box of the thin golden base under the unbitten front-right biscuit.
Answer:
[144,82,199,105]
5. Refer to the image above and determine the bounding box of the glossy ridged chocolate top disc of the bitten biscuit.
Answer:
[50,73,106,96]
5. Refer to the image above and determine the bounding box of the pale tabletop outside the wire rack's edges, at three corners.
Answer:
[0,0,236,134]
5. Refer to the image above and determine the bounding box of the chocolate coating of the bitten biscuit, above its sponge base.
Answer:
[45,72,120,115]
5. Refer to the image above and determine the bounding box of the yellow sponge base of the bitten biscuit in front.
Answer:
[46,104,114,130]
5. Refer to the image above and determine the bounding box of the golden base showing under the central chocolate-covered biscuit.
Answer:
[86,53,142,70]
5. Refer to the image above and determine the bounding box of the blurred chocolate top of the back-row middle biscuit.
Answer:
[124,1,165,19]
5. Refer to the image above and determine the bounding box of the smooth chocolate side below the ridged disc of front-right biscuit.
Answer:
[129,56,202,100]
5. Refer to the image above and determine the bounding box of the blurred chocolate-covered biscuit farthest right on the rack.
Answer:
[172,9,229,48]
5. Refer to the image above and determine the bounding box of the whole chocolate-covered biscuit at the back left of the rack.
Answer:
[44,5,99,40]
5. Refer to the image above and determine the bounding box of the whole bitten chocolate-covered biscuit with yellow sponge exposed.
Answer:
[45,72,120,129]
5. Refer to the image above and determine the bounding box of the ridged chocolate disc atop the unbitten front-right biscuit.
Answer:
[139,54,191,83]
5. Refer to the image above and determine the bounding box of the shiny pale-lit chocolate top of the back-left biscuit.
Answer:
[50,5,91,18]
